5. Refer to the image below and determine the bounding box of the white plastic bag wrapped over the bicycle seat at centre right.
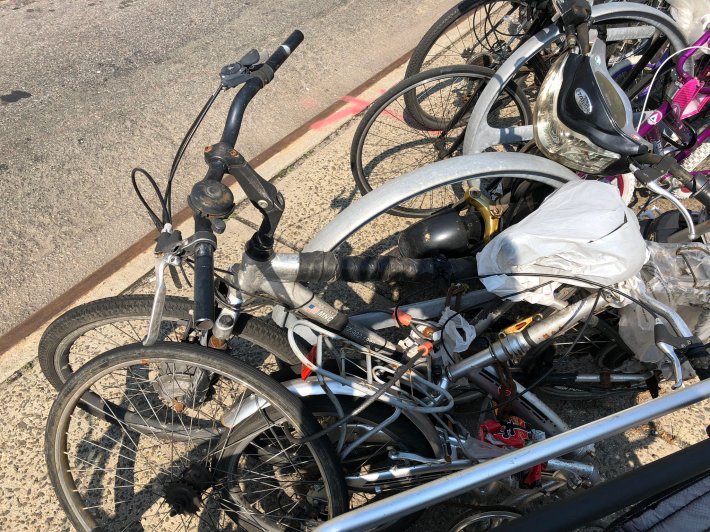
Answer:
[477,180,646,306]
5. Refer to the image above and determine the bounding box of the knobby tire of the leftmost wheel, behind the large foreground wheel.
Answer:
[37,295,298,390]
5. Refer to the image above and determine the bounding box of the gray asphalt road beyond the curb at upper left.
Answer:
[0,0,453,334]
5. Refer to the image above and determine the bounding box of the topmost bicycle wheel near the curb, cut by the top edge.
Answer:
[405,0,528,77]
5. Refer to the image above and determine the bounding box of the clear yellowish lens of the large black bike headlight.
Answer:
[533,54,621,174]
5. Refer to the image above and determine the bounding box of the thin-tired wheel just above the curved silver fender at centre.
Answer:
[350,65,532,217]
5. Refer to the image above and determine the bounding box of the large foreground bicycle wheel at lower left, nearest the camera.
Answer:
[45,343,347,530]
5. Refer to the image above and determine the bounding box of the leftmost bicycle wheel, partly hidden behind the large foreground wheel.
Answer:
[38,295,298,389]
